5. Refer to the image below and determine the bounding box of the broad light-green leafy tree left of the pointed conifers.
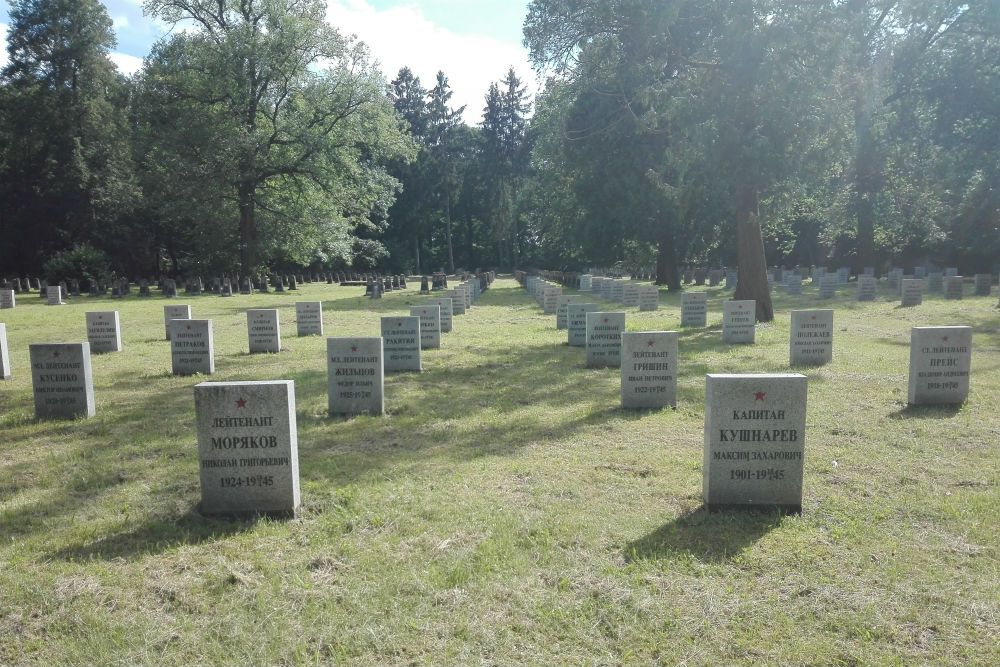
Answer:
[145,0,414,275]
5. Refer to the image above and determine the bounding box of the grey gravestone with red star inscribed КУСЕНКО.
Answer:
[28,343,97,419]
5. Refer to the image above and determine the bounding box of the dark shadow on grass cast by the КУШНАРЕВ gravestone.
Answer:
[624,505,784,562]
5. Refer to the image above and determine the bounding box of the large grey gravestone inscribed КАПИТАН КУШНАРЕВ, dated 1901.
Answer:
[702,373,808,512]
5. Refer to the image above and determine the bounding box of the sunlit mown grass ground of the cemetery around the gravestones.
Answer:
[0,278,1000,665]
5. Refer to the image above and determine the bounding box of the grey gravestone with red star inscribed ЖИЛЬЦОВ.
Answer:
[326,338,385,416]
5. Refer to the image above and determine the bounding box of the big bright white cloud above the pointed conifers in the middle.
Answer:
[327,0,537,125]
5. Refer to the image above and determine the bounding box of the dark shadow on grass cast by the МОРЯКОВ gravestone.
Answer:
[52,506,261,561]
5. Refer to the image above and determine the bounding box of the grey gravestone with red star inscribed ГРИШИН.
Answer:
[621,331,677,408]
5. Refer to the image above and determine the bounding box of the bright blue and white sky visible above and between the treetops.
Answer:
[0,0,537,124]
